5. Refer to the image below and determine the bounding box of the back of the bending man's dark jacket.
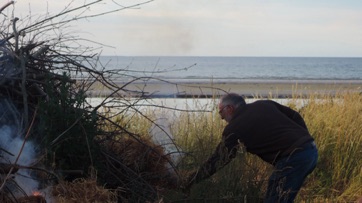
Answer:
[223,100,313,164]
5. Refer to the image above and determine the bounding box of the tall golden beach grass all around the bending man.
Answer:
[108,92,362,202]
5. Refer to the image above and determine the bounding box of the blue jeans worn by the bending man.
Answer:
[264,142,318,203]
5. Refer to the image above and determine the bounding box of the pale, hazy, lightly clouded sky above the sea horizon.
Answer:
[7,0,362,57]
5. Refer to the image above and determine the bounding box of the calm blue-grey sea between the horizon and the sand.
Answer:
[101,56,362,82]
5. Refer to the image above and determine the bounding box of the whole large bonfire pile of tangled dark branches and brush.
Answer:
[0,1,184,203]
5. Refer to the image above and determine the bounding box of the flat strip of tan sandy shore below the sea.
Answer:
[88,80,362,98]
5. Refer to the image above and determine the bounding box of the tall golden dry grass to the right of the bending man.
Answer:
[296,93,362,202]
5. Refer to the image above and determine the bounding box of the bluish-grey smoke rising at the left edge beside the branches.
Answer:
[0,99,39,196]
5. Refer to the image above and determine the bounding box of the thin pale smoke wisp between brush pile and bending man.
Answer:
[150,115,183,170]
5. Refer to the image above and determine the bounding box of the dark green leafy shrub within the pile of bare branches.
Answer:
[37,74,99,179]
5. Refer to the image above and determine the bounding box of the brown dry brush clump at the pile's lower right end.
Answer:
[99,133,181,201]
